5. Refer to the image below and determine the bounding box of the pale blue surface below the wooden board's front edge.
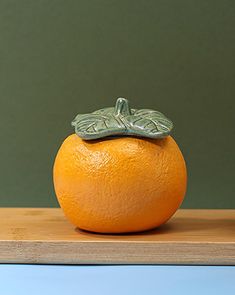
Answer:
[0,264,235,295]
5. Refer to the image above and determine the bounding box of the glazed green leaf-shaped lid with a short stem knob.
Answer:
[72,98,173,140]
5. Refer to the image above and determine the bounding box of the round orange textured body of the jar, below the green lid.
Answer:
[53,134,187,233]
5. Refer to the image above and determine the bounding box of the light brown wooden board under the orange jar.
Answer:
[0,208,235,265]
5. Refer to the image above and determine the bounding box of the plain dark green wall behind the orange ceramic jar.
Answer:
[0,0,235,208]
